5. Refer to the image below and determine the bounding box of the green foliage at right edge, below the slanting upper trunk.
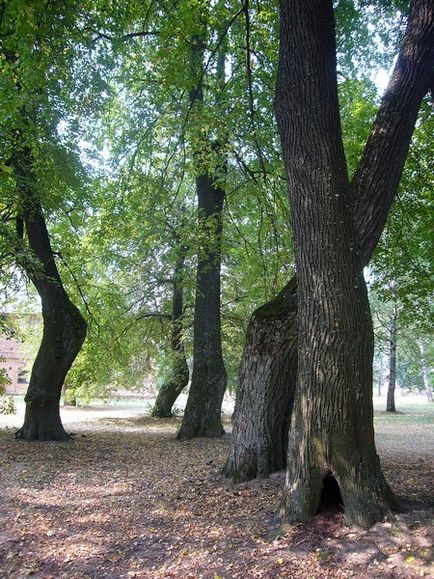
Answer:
[372,102,434,333]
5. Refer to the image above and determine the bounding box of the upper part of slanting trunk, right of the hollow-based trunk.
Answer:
[351,0,434,266]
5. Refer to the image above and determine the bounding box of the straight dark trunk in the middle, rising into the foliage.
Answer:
[178,24,227,439]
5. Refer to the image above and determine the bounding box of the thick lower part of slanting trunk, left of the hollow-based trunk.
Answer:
[225,278,297,482]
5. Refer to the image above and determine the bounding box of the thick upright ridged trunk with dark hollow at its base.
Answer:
[276,0,392,526]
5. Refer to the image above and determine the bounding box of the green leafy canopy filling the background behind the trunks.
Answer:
[0,0,434,399]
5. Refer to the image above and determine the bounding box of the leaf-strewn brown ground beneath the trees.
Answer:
[0,405,434,579]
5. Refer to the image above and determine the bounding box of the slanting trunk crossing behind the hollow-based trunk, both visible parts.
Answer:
[225,0,434,480]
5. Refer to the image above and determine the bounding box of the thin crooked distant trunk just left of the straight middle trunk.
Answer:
[152,248,189,418]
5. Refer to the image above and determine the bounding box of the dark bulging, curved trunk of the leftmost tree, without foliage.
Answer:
[13,148,87,440]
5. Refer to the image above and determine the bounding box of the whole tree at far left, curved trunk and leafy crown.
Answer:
[0,1,100,440]
